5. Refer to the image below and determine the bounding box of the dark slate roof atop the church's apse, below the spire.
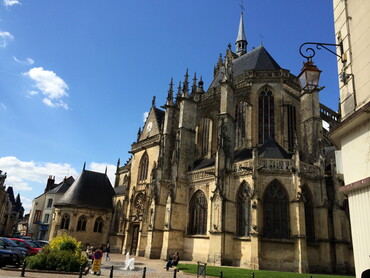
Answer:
[210,45,281,88]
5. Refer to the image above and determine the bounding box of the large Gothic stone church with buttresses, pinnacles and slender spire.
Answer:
[111,12,353,273]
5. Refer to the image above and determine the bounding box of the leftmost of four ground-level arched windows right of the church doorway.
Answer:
[188,190,207,235]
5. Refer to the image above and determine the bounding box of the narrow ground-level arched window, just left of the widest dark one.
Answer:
[236,182,251,236]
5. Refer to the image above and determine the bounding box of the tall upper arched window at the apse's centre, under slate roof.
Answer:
[258,88,275,144]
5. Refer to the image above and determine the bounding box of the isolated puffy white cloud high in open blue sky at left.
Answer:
[23,67,69,110]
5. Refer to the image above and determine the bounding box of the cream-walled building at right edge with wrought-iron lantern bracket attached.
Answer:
[329,0,370,278]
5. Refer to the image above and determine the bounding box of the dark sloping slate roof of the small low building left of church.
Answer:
[55,170,114,210]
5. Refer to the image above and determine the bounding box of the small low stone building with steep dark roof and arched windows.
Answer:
[49,165,115,246]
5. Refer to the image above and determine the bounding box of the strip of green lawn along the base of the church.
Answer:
[178,264,354,278]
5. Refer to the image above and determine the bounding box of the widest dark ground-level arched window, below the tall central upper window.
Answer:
[263,180,289,238]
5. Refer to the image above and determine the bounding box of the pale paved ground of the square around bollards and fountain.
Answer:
[0,254,196,278]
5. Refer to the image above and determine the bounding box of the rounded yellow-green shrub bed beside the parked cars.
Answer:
[27,235,87,272]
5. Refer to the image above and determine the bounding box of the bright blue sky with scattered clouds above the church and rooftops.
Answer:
[0,0,339,212]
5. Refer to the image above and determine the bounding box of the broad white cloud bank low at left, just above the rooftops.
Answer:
[0,156,77,193]
